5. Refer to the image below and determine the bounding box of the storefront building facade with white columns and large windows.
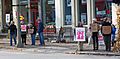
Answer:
[0,0,112,32]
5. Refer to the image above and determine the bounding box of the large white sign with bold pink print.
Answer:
[74,27,85,41]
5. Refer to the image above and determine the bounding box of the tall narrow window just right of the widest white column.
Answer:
[64,0,72,25]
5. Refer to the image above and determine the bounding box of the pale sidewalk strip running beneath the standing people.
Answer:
[0,39,120,56]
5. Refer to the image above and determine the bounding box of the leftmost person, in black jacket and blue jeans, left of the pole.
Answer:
[10,21,17,46]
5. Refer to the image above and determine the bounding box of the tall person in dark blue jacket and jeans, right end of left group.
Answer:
[38,19,45,46]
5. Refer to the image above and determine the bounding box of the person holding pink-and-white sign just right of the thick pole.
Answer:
[21,21,27,45]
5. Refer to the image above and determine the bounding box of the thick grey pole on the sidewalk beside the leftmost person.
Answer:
[17,0,24,48]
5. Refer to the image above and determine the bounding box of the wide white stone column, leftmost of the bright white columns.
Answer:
[55,0,64,28]
